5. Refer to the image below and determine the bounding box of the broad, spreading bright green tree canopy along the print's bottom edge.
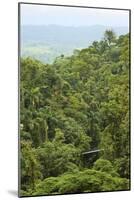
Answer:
[33,169,128,195]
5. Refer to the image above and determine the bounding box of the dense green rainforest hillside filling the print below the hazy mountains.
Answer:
[20,30,130,196]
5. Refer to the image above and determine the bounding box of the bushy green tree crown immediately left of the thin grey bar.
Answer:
[37,140,80,178]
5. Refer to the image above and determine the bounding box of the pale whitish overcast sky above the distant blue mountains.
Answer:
[21,4,129,26]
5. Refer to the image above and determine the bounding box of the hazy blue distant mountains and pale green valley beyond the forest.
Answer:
[21,25,129,63]
